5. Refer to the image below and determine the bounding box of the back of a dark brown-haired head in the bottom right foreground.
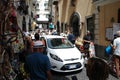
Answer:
[86,57,109,80]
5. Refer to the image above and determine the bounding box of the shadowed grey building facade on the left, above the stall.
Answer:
[13,0,34,32]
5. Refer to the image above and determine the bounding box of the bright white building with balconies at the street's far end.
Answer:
[35,0,50,28]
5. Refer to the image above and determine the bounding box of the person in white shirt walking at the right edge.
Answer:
[113,31,120,78]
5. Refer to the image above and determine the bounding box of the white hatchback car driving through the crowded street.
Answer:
[42,35,84,72]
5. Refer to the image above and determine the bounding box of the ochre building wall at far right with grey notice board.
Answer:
[93,0,120,46]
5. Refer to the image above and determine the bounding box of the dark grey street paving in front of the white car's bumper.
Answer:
[52,68,120,80]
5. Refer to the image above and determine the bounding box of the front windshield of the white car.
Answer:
[47,38,74,49]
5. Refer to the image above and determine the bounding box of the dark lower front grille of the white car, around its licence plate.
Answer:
[61,62,82,70]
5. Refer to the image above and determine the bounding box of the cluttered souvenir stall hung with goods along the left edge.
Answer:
[0,0,25,80]
